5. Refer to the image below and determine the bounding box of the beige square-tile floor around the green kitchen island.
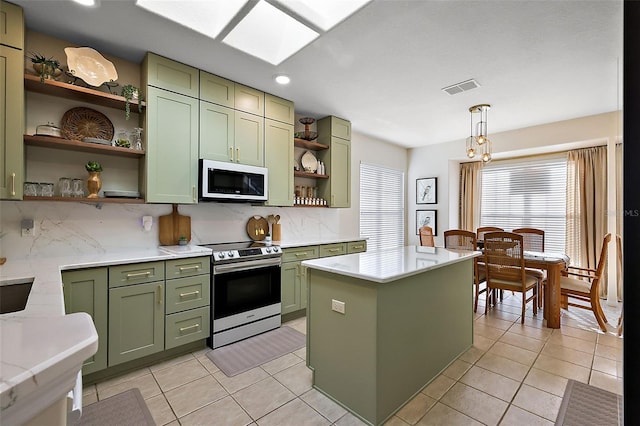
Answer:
[84,295,622,426]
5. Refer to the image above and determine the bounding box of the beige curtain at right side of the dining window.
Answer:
[566,146,607,297]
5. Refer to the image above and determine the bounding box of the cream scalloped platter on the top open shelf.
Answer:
[64,47,118,87]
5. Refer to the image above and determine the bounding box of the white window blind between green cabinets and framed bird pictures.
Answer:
[360,163,404,250]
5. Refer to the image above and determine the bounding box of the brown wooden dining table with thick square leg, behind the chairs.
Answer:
[477,240,569,328]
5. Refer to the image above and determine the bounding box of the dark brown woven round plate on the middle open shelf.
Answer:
[61,107,113,141]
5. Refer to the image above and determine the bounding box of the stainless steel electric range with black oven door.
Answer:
[205,241,282,349]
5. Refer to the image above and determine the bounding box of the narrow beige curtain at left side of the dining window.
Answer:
[458,161,482,232]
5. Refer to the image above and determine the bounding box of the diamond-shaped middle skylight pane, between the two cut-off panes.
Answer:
[222,1,319,65]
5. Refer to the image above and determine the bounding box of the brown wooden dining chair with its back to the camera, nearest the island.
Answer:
[484,232,538,324]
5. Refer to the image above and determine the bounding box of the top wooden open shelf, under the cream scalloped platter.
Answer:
[24,74,146,113]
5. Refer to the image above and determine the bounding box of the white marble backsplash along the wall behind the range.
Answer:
[0,201,348,260]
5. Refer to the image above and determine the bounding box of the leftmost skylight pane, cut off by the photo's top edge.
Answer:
[136,0,247,38]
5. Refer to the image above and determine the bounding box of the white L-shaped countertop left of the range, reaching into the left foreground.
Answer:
[0,245,211,423]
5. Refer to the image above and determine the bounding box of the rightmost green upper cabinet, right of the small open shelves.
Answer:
[317,116,351,207]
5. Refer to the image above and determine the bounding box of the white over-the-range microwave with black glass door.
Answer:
[198,159,269,202]
